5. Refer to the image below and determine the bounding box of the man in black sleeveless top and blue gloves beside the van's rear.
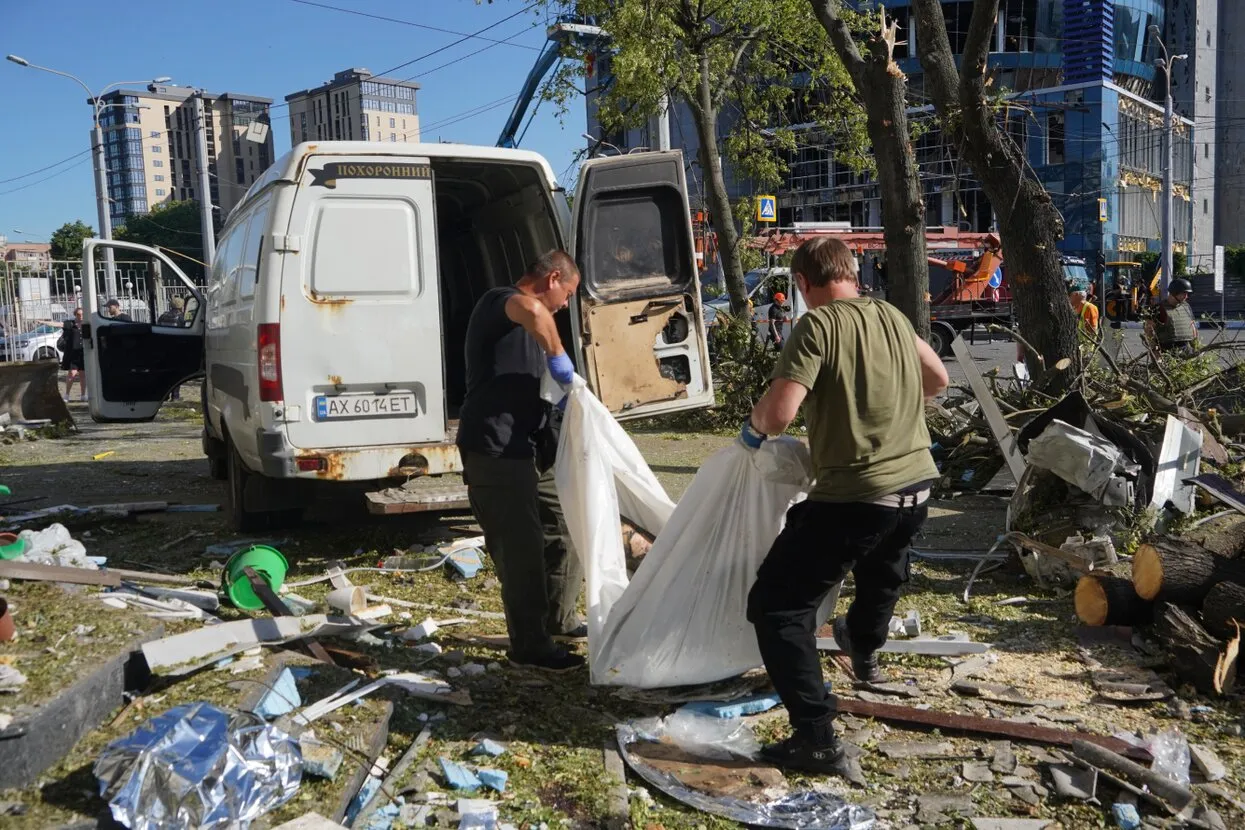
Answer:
[458,250,588,672]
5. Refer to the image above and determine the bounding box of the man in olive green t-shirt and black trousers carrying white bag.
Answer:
[740,238,947,773]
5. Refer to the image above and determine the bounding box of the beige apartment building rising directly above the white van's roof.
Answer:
[285,67,420,146]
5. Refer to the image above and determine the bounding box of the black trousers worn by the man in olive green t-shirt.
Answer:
[748,501,928,743]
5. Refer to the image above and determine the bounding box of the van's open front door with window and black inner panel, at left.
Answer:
[82,239,205,422]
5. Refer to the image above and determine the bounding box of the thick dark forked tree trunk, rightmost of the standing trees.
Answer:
[913,0,1077,377]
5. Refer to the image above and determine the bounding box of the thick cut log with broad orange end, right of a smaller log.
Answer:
[1133,536,1245,606]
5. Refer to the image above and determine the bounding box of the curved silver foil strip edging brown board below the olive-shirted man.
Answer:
[615,719,874,830]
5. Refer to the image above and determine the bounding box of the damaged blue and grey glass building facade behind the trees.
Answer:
[588,0,1230,270]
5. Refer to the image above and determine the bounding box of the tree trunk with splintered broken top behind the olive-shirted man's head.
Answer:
[809,0,930,340]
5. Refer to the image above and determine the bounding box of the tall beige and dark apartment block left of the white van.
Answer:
[100,83,274,228]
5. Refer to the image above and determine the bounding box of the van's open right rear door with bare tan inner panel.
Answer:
[571,151,713,418]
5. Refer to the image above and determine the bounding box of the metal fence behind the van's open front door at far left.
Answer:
[0,258,201,337]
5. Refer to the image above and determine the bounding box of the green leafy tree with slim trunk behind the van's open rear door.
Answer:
[542,0,864,314]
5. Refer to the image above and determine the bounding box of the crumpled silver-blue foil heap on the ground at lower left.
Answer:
[95,703,303,830]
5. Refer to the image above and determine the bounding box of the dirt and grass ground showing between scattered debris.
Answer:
[0,395,1245,830]
